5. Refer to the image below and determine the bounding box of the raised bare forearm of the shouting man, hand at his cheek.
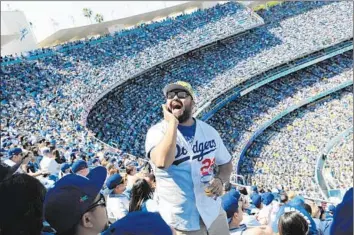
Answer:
[150,122,178,168]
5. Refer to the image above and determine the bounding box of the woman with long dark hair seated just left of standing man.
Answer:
[129,179,158,212]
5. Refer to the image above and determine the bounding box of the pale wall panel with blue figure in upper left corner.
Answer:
[1,11,38,56]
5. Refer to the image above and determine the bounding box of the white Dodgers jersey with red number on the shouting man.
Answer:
[145,120,231,231]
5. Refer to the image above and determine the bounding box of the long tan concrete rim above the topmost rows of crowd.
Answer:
[38,1,227,47]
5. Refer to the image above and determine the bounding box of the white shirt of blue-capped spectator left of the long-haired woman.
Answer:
[107,193,129,222]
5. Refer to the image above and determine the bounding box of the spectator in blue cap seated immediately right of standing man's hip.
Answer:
[222,189,273,235]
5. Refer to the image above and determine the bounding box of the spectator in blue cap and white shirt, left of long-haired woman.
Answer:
[106,174,129,222]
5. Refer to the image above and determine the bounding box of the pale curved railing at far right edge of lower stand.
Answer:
[315,126,353,198]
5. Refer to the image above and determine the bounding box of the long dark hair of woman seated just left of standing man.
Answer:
[129,179,153,212]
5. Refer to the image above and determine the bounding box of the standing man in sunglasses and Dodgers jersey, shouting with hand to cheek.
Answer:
[145,81,233,235]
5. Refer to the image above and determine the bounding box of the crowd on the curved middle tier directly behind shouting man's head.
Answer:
[87,2,352,155]
